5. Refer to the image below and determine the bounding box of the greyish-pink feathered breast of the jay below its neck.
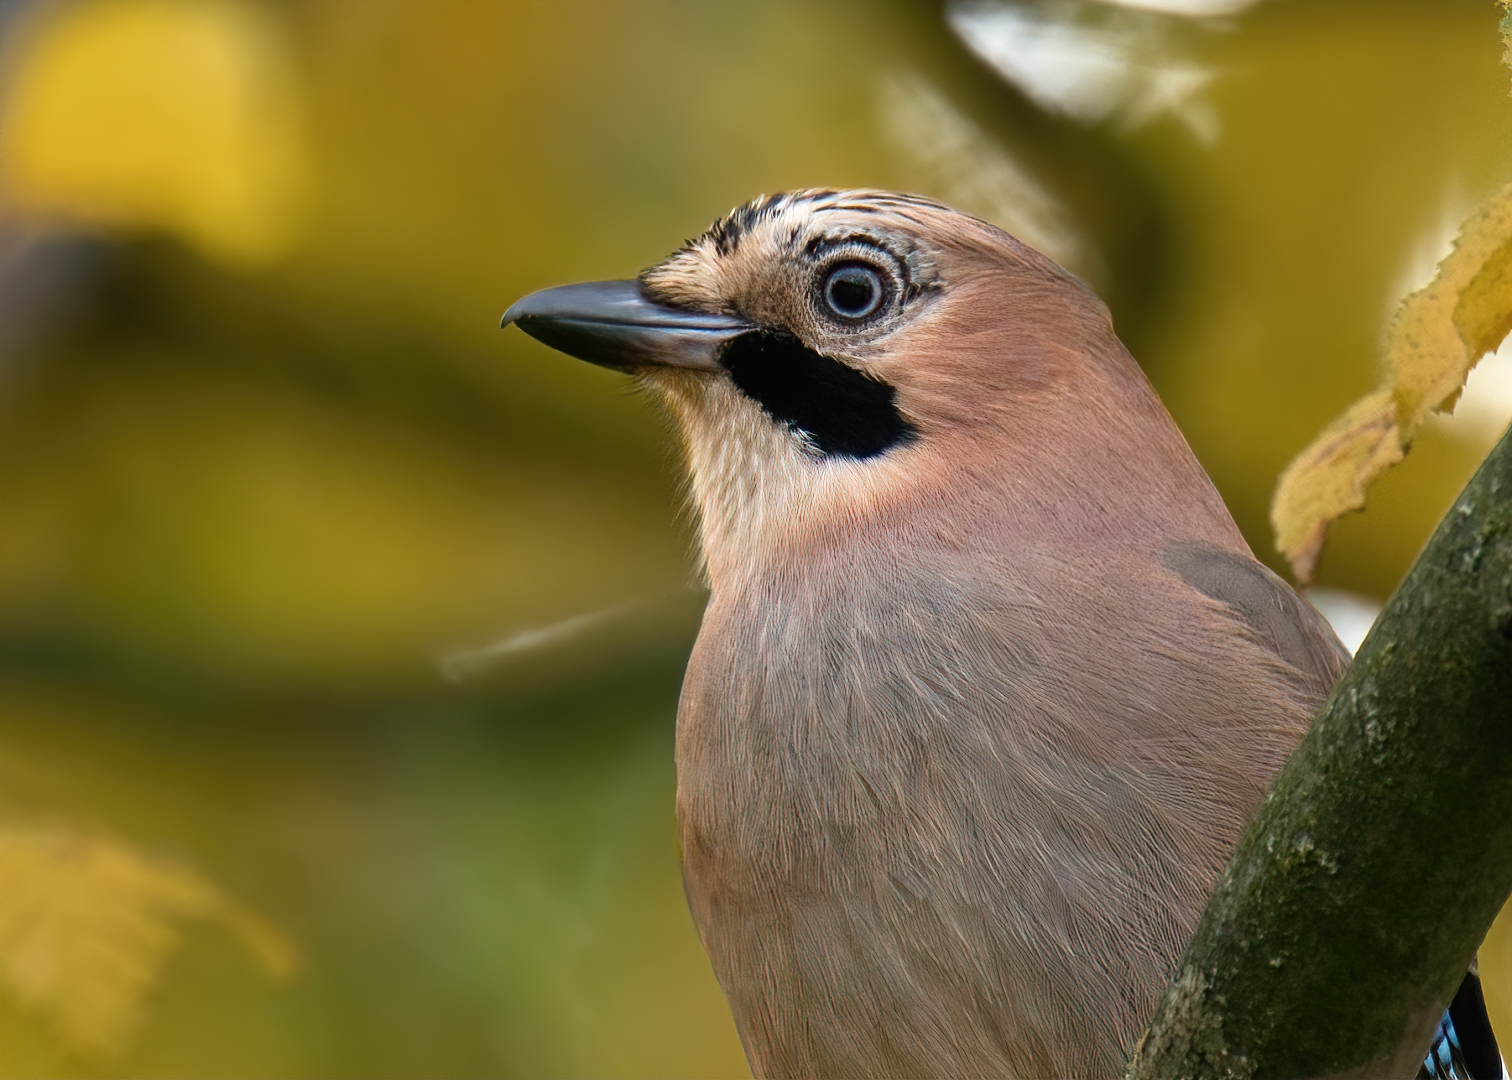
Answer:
[677,532,1306,1075]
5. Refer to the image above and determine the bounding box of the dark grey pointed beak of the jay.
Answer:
[499,281,756,372]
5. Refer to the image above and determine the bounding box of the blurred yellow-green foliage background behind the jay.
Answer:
[0,0,1512,1077]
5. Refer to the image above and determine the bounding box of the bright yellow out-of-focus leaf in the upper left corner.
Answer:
[0,0,308,268]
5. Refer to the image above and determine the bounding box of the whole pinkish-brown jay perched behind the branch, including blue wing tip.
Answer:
[503,191,1501,1077]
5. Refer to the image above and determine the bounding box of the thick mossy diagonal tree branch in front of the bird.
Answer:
[1126,433,1512,1080]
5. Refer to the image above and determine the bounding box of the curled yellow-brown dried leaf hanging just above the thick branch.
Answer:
[1270,185,1512,584]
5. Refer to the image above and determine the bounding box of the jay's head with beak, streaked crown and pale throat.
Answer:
[503,191,1203,584]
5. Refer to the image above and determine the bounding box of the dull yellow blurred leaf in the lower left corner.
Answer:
[0,826,301,1056]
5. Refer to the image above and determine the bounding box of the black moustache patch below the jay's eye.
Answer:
[720,330,918,458]
